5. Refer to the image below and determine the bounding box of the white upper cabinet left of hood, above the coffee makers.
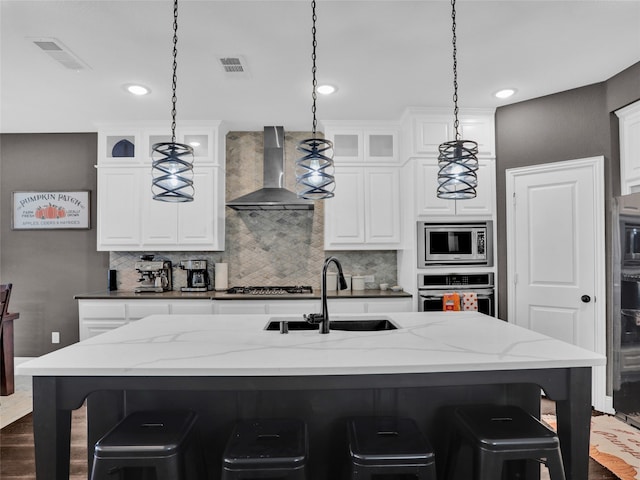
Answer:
[97,122,226,251]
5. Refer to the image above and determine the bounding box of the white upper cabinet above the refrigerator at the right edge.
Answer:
[616,101,640,195]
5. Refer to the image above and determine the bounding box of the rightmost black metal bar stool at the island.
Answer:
[446,405,565,480]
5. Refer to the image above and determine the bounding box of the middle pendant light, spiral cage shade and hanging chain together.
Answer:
[296,0,336,200]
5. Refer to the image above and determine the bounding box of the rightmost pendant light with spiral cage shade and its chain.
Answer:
[438,0,478,200]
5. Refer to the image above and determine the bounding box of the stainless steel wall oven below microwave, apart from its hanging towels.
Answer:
[418,272,496,316]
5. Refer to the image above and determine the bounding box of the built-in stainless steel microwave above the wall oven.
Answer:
[418,221,493,268]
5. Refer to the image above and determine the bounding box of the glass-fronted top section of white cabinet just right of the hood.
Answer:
[325,122,400,165]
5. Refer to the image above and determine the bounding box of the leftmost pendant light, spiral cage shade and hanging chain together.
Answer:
[151,0,194,202]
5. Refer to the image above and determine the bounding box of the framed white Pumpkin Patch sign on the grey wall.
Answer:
[12,190,91,230]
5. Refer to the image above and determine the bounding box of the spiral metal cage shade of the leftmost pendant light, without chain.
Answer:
[151,142,194,202]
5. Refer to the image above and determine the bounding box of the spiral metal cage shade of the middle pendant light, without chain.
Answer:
[296,138,336,200]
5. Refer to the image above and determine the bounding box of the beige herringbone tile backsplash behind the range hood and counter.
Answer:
[109,131,397,291]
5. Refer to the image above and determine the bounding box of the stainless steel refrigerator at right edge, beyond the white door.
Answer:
[607,193,640,428]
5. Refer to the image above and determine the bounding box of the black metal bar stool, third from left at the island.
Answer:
[347,417,436,480]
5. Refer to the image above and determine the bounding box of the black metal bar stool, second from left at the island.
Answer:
[222,418,309,480]
